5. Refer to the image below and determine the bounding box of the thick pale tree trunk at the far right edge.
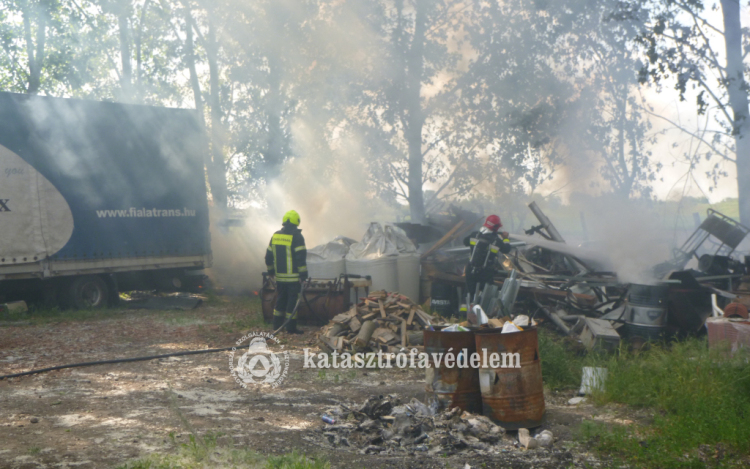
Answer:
[721,0,750,226]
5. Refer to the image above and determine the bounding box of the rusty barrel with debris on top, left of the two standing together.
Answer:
[424,326,482,413]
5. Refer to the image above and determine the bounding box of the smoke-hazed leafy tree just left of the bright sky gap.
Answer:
[557,1,661,198]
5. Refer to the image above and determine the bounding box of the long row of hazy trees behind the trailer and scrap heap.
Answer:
[0,0,688,215]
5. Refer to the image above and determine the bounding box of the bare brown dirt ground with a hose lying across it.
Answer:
[0,298,627,469]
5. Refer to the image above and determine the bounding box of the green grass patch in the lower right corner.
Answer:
[581,339,750,468]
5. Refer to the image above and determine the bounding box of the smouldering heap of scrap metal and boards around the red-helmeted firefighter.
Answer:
[422,203,750,350]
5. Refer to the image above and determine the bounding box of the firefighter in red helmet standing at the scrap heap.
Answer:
[464,215,510,298]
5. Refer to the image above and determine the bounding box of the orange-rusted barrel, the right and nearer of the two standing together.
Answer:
[475,327,544,430]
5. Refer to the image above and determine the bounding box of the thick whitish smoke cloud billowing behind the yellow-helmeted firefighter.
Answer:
[204,120,395,292]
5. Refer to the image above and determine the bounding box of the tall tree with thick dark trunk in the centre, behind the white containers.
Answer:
[346,0,494,222]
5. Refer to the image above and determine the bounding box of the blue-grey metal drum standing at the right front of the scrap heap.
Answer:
[623,283,669,340]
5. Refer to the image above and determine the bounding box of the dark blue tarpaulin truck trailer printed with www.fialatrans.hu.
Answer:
[0,93,211,308]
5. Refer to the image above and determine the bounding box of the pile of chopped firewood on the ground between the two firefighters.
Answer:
[318,291,441,353]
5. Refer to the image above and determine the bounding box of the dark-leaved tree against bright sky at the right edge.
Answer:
[619,0,750,224]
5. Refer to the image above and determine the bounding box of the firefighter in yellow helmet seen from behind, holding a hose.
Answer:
[266,210,307,334]
